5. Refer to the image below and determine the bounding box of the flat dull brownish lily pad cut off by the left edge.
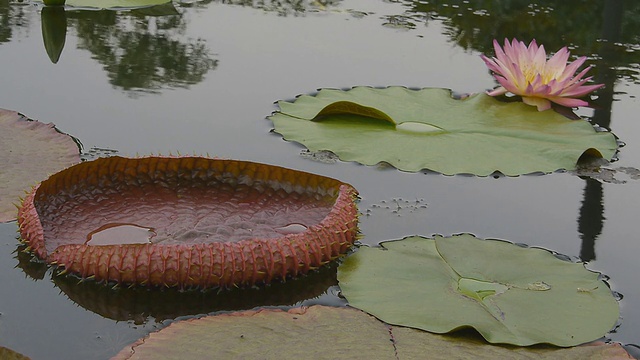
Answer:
[0,109,80,222]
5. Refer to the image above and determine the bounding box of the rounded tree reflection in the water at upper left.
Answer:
[66,3,218,92]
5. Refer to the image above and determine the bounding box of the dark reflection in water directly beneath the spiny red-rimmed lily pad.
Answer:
[15,245,338,325]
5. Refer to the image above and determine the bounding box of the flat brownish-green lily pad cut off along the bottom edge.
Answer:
[112,305,632,360]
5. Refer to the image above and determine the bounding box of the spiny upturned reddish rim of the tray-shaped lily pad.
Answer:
[18,156,358,288]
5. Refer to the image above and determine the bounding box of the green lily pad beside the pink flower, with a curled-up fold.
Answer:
[269,87,618,176]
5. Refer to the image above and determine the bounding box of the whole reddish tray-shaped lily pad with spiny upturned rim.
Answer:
[18,156,358,288]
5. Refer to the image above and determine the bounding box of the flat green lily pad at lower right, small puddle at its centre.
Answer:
[338,234,619,347]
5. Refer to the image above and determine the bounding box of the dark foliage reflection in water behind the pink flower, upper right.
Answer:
[402,0,640,81]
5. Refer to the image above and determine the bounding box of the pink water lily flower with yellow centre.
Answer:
[480,39,604,111]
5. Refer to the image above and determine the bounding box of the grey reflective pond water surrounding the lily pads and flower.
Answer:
[0,0,640,359]
